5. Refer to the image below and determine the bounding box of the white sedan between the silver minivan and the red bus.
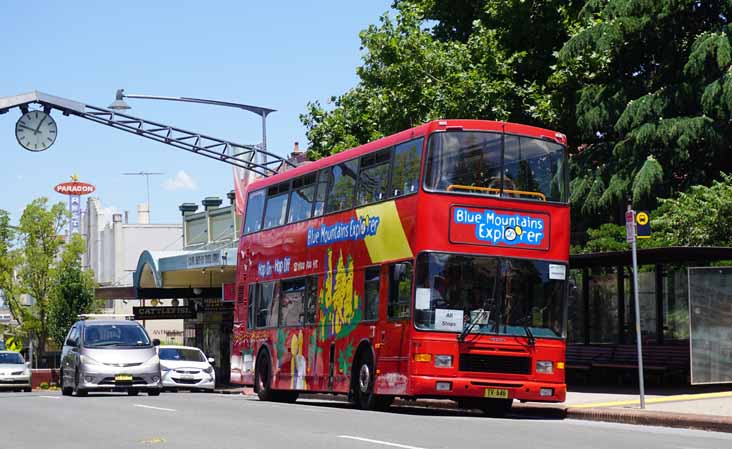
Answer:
[158,346,216,390]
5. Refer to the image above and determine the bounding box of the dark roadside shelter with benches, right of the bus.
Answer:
[567,247,732,385]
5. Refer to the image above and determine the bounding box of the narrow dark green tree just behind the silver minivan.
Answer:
[48,234,100,346]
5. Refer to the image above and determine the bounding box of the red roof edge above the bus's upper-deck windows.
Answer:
[247,119,567,191]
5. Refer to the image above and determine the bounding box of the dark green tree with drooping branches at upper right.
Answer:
[550,0,732,223]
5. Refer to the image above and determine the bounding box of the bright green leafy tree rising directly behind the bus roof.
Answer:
[300,0,578,158]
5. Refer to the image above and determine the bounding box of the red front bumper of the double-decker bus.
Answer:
[409,376,567,402]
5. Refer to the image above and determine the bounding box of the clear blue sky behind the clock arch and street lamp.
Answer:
[0,0,391,223]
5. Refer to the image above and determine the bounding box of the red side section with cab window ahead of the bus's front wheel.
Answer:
[374,262,412,395]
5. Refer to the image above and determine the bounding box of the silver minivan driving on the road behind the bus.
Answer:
[61,320,162,396]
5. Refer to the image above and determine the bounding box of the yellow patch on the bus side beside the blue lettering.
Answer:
[356,201,413,263]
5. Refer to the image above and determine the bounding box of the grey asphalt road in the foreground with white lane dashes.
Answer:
[0,392,732,449]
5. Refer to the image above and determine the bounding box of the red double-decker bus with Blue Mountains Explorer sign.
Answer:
[232,120,569,413]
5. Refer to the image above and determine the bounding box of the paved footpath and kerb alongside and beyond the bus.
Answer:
[216,386,732,433]
